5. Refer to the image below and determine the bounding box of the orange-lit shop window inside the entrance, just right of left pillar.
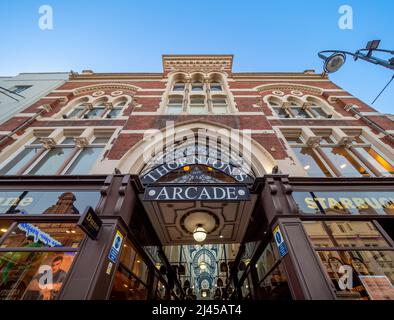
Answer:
[110,239,148,300]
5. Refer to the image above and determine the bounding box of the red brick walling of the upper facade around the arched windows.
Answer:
[0,74,394,165]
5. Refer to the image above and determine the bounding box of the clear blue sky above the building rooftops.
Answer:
[0,0,394,113]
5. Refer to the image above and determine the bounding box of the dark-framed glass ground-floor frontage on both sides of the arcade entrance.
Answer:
[0,175,394,300]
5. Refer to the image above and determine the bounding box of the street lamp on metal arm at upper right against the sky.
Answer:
[318,40,394,73]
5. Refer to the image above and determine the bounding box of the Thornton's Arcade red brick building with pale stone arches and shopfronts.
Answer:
[0,55,394,299]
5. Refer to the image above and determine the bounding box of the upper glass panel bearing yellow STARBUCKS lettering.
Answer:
[292,190,394,215]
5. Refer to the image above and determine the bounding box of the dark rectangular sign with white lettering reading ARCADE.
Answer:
[144,184,250,201]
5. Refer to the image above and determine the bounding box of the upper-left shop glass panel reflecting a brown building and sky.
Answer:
[0,190,100,214]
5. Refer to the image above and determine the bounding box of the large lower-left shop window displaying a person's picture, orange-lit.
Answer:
[0,251,76,300]
